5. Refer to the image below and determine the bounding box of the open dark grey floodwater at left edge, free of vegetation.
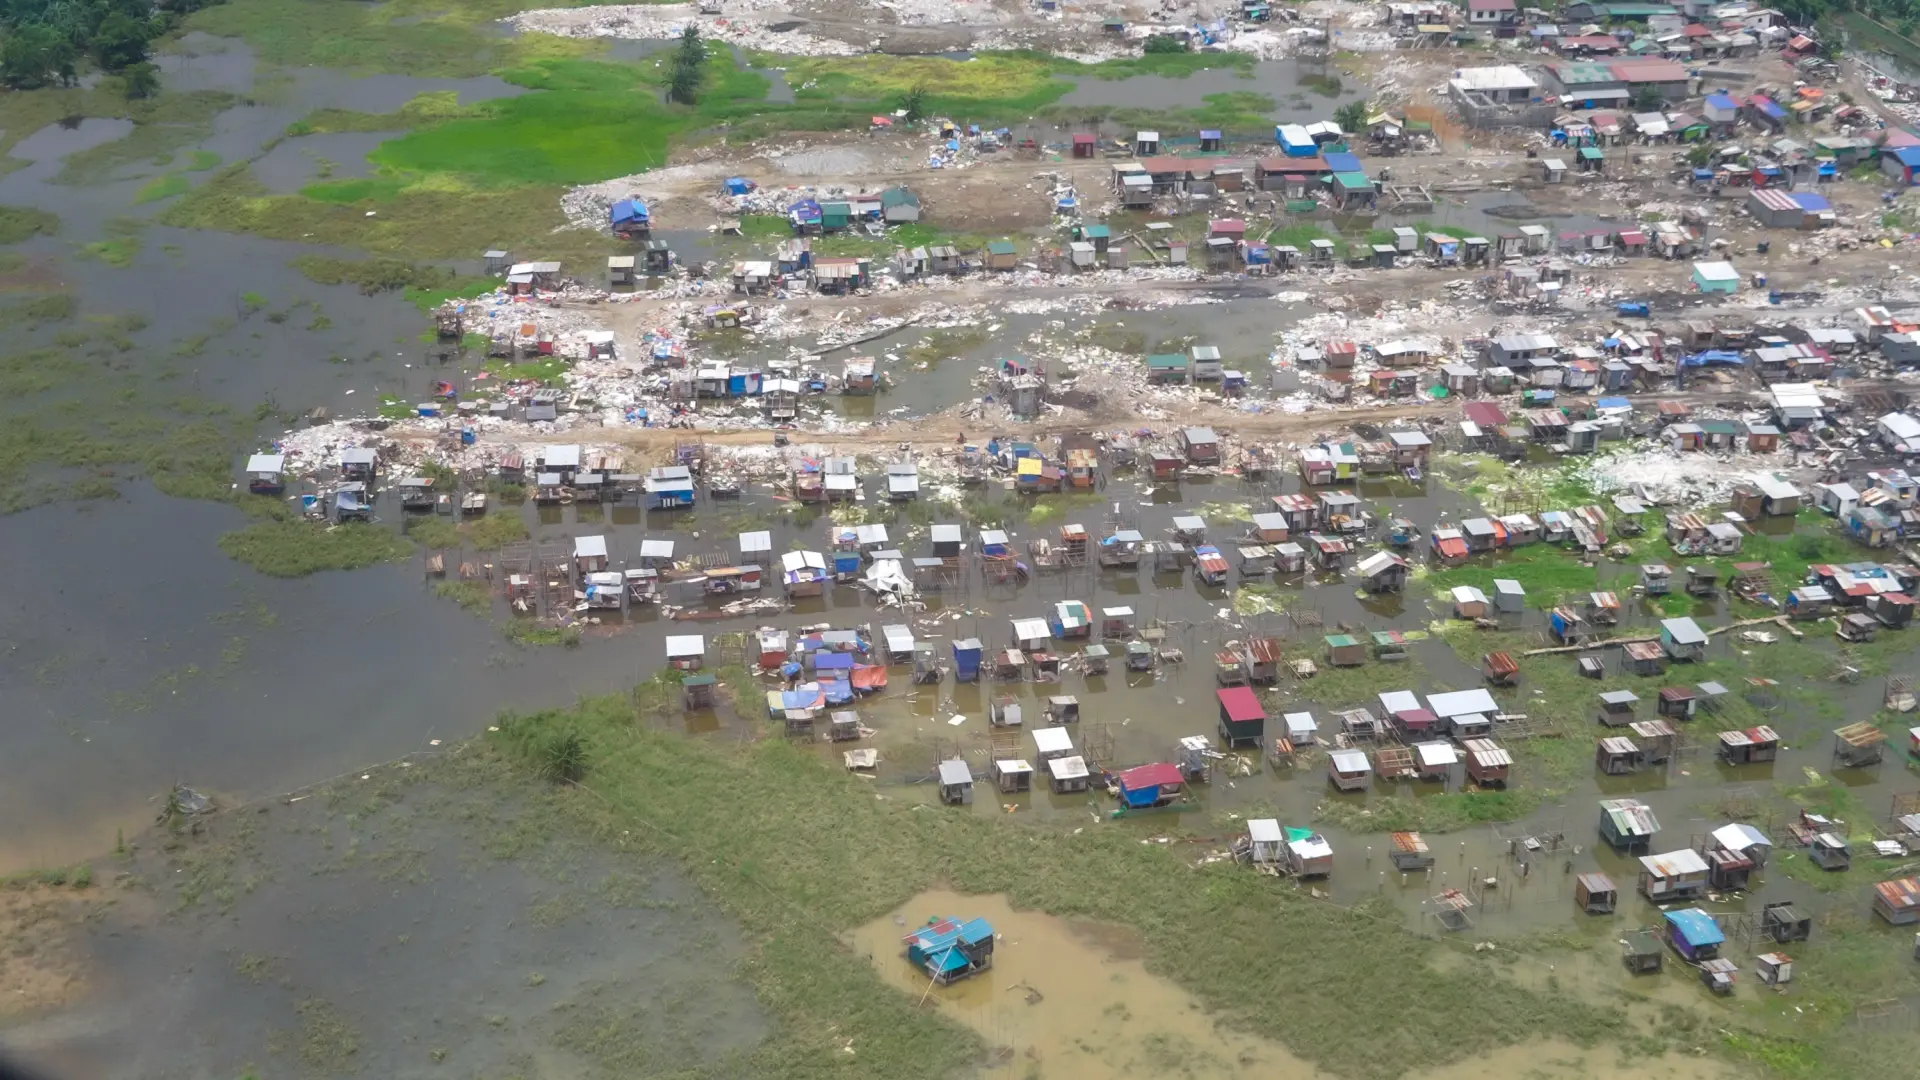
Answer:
[0,486,643,869]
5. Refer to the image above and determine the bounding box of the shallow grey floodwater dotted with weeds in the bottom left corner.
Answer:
[6,767,772,1080]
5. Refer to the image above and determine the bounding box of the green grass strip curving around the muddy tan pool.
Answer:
[480,698,1651,1078]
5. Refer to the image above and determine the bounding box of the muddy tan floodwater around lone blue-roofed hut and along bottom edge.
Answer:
[852,890,1734,1080]
